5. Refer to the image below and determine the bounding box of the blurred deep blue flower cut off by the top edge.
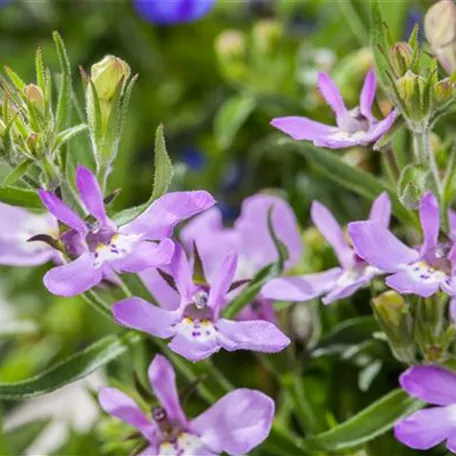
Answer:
[133,0,215,25]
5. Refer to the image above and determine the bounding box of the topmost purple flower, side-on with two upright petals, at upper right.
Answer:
[271,70,398,149]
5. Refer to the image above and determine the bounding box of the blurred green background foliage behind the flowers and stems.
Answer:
[0,0,442,456]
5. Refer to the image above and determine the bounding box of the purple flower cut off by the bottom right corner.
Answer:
[394,366,456,453]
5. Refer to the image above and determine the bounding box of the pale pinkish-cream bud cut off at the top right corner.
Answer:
[424,0,456,73]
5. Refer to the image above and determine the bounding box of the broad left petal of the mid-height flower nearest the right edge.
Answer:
[348,221,419,272]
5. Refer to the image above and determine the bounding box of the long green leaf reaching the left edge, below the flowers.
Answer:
[0,332,141,400]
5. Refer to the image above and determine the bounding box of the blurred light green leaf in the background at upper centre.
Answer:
[214,95,256,150]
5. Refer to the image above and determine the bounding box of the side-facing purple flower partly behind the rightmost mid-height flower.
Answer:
[263,193,391,304]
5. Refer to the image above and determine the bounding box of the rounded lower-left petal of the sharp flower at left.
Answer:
[43,252,102,297]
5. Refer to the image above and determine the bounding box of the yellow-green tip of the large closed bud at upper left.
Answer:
[90,55,130,101]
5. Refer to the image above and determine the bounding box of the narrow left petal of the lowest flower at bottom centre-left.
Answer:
[98,388,158,443]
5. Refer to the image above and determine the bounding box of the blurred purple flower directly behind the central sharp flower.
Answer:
[181,194,302,323]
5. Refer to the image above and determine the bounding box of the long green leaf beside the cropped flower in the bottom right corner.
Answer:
[304,389,424,451]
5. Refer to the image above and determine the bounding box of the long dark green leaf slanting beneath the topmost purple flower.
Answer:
[281,139,419,228]
